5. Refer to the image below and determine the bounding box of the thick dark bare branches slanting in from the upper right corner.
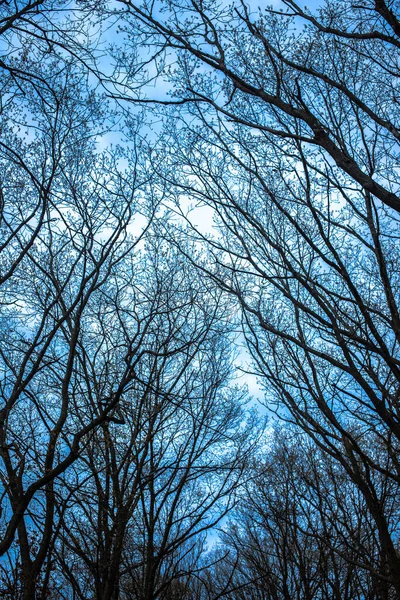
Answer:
[116,0,400,212]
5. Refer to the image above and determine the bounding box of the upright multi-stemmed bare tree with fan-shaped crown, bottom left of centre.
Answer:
[51,242,259,600]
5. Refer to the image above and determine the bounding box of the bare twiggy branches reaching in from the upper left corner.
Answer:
[0,0,109,285]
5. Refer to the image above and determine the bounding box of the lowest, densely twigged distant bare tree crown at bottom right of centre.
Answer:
[202,428,399,600]
